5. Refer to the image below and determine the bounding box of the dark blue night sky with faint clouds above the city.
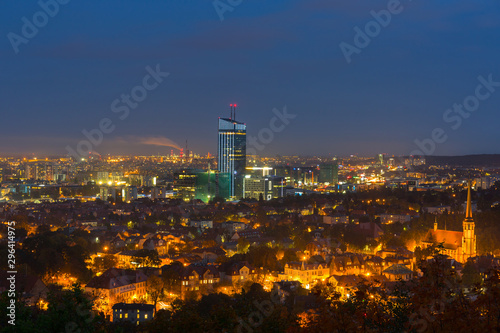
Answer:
[0,0,500,156]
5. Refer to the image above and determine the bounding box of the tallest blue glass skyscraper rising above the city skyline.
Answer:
[217,118,247,199]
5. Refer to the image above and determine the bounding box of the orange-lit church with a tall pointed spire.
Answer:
[422,181,477,263]
